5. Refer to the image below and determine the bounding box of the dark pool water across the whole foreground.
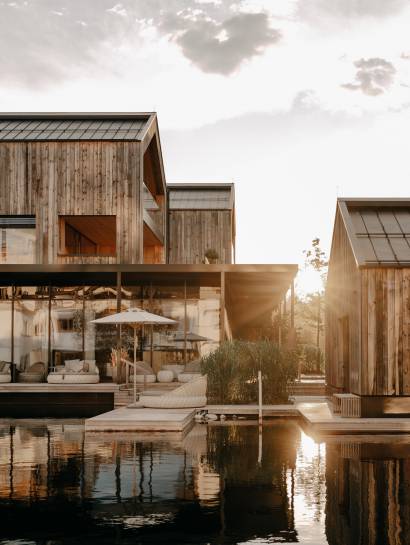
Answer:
[0,420,410,545]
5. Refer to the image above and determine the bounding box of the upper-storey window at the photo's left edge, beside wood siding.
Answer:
[0,216,36,264]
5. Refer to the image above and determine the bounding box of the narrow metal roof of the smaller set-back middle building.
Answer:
[167,183,235,210]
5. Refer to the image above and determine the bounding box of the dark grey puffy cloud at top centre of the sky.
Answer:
[166,13,281,75]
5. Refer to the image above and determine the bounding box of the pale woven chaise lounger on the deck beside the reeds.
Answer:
[138,375,207,409]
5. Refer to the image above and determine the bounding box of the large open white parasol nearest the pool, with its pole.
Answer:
[91,308,177,403]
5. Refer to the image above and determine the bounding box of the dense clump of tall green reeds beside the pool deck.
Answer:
[201,340,297,404]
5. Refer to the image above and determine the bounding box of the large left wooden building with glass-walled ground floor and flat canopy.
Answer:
[0,114,297,394]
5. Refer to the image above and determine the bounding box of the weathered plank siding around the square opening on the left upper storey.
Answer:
[0,141,142,264]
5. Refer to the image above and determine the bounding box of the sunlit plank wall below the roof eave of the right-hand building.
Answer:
[360,268,410,395]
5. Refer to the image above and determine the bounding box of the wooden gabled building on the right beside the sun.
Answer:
[326,199,410,416]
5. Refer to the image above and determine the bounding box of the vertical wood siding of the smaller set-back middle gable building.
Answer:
[168,210,233,264]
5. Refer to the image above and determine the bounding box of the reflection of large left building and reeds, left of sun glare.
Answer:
[0,420,299,544]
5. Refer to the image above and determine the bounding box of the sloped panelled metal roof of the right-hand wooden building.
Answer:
[338,198,410,267]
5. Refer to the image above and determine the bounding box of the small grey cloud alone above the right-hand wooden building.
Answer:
[342,57,396,96]
